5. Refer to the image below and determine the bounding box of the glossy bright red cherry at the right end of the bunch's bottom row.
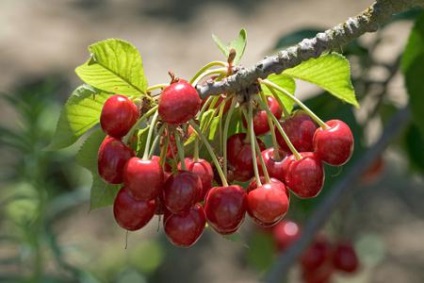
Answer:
[247,179,289,225]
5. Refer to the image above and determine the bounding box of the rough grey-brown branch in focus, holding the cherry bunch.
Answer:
[197,0,424,99]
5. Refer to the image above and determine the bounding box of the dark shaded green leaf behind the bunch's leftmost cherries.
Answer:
[76,129,120,209]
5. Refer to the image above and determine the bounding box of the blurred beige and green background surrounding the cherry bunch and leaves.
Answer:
[0,0,424,282]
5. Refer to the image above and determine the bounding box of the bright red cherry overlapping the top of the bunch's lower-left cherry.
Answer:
[124,156,164,200]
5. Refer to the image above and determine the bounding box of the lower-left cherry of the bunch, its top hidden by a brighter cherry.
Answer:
[113,187,156,231]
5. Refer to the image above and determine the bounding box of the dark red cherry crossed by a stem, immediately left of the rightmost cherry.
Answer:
[275,110,318,152]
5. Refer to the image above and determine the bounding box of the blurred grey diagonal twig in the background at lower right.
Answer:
[265,107,411,283]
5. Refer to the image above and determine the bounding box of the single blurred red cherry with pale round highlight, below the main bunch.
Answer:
[272,220,301,252]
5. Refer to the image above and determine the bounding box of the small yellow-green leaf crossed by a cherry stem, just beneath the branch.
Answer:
[262,74,296,114]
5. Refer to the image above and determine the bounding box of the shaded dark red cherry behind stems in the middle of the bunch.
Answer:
[227,133,265,182]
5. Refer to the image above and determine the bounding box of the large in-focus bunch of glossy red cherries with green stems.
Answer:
[98,77,353,247]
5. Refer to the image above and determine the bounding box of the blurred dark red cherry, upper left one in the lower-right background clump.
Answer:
[300,236,332,271]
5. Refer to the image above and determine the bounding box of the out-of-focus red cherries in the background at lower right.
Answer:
[270,220,360,283]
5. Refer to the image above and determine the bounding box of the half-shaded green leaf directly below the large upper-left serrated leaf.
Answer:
[47,85,110,150]
